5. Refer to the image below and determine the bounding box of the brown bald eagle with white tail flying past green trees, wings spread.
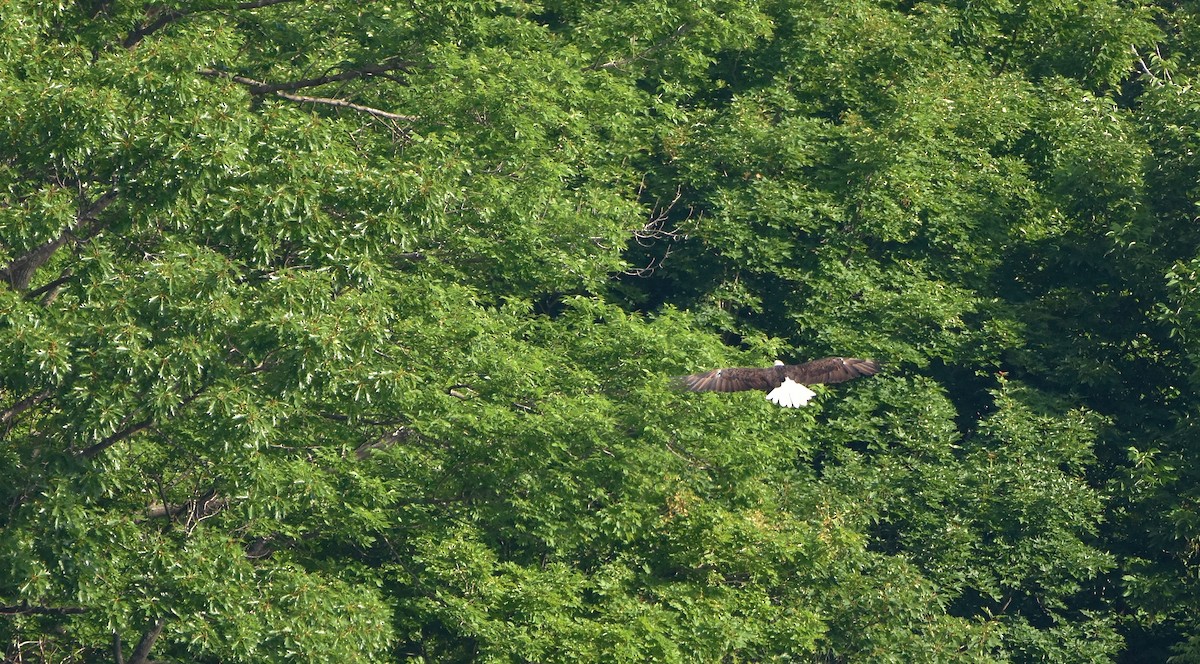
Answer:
[680,358,880,408]
